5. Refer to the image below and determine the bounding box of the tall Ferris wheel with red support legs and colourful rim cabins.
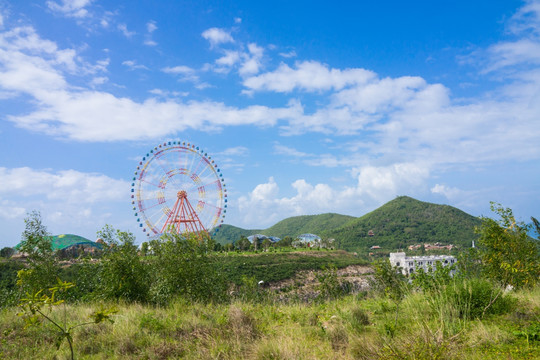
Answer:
[131,141,227,237]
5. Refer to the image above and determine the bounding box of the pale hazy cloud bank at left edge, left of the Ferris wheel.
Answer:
[0,167,130,242]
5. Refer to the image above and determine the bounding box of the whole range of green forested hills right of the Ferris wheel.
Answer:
[214,196,480,250]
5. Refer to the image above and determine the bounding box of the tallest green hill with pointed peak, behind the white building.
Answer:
[322,196,481,250]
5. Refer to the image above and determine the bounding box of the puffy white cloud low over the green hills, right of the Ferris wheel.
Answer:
[238,163,429,227]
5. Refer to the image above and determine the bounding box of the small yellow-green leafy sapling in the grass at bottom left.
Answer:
[17,270,117,360]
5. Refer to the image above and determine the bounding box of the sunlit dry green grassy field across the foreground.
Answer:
[0,274,540,360]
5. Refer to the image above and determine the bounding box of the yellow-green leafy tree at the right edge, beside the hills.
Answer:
[477,202,540,288]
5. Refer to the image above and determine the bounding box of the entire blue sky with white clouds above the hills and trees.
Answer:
[0,0,540,246]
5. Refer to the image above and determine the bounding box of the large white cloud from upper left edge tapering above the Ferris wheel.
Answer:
[0,23,299,141]
